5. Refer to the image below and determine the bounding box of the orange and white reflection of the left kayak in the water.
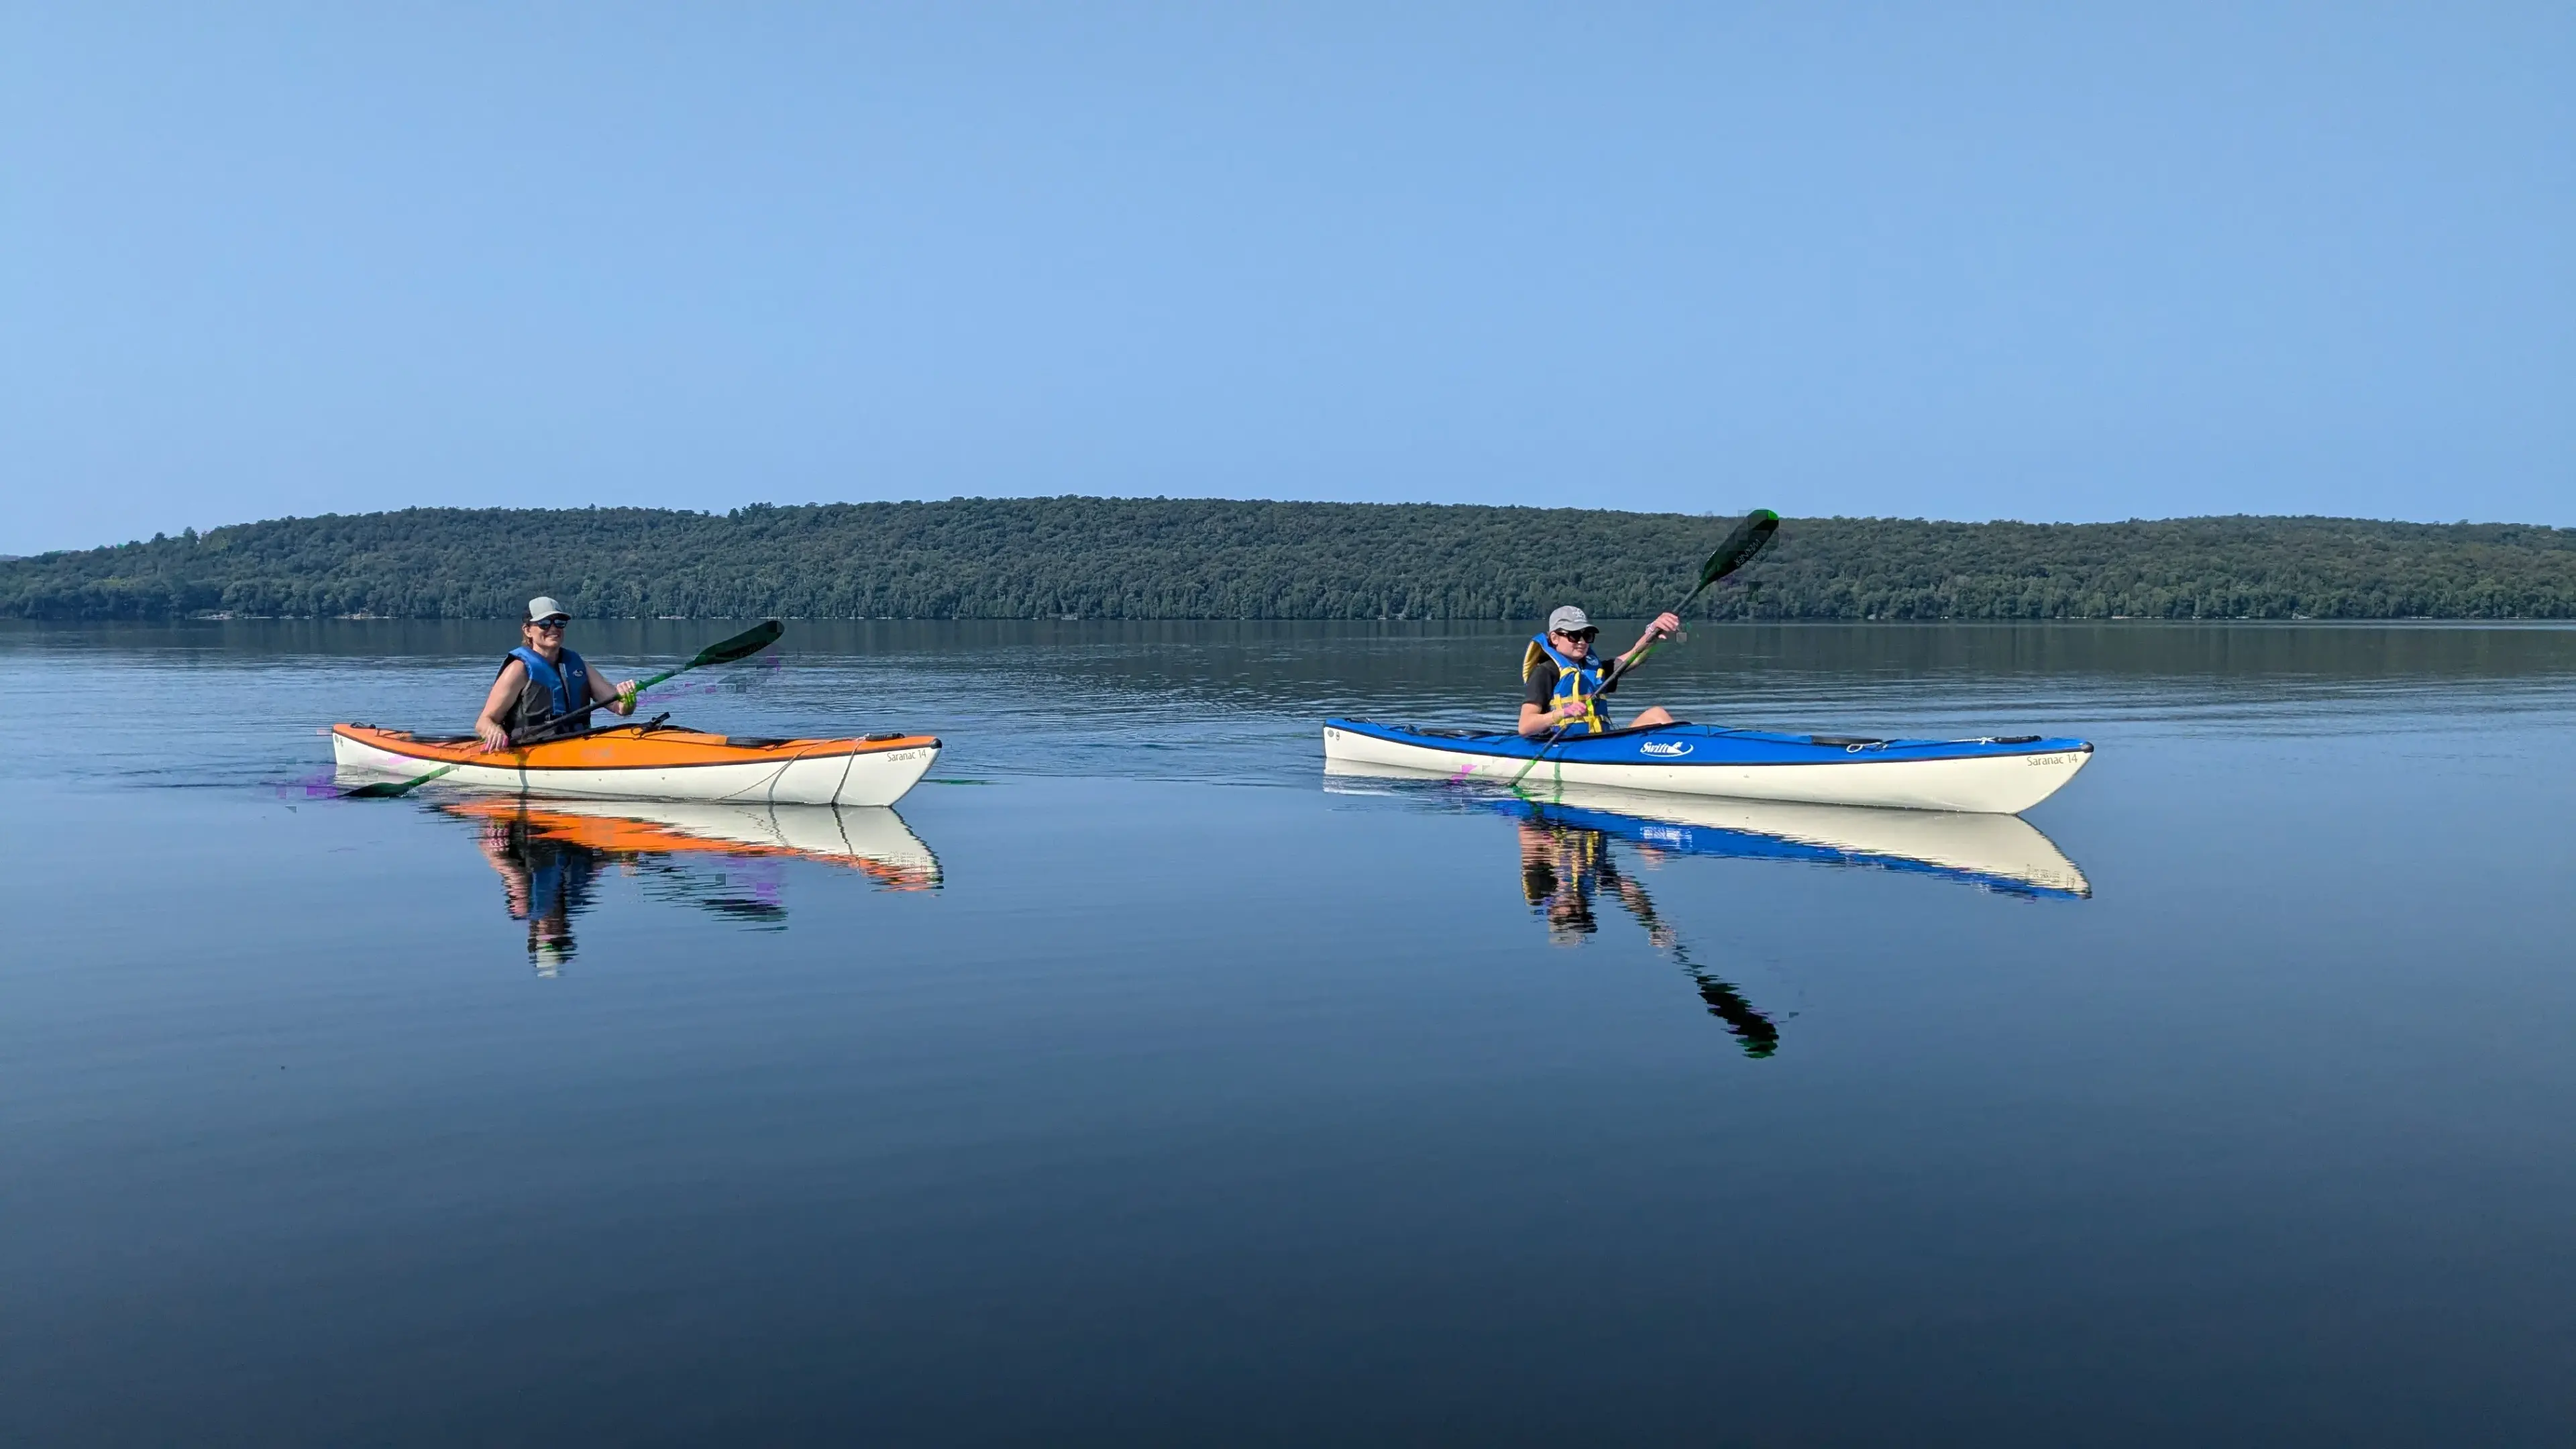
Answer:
[441,799,941,890]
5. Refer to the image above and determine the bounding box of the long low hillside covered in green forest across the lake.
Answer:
[0,498,2576,619]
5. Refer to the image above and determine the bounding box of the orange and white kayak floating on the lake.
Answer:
[332,724,941,804]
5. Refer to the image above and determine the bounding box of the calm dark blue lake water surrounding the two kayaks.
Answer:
[0,621,2576,1446]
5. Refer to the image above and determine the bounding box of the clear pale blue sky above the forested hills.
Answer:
[0,0,2576,551]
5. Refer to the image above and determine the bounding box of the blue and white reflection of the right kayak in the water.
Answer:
[1324,761,2092,898]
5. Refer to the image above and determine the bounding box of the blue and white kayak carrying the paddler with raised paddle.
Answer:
[1324,719,2092,815]
